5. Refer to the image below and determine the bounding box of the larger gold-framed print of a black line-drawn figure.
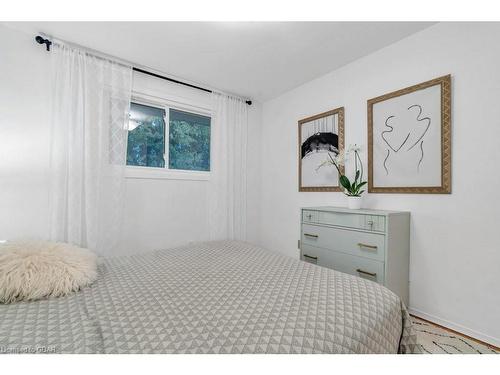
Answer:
[368,75,451,194]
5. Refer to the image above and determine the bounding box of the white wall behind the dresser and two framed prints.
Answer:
[261,23,500,345]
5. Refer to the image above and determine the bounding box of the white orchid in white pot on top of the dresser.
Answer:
[318,144,366,209]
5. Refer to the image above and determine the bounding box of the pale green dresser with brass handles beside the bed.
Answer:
[299,207,410,306]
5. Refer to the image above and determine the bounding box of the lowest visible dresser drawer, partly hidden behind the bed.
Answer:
[302,245,385,284]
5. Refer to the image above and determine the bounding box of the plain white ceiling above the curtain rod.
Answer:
[7,22,433,101]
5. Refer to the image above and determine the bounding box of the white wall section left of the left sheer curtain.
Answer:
[0,25,50,240]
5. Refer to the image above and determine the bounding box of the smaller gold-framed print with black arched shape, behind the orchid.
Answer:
[299,107,344,191]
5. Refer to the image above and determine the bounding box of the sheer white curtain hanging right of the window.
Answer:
[209,93,248,240]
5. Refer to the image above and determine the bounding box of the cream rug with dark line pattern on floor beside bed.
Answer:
[411,316,500,354]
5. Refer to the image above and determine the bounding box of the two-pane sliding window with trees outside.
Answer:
[127,103,211,172]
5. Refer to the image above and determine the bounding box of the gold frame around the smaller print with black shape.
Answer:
[298,107,344,192]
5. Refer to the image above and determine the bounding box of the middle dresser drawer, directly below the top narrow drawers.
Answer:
[301,224,385,262]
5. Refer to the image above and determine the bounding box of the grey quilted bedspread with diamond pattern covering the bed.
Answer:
[0,241,419,353]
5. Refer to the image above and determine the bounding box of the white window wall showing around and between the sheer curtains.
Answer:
[0,25,262,253]
